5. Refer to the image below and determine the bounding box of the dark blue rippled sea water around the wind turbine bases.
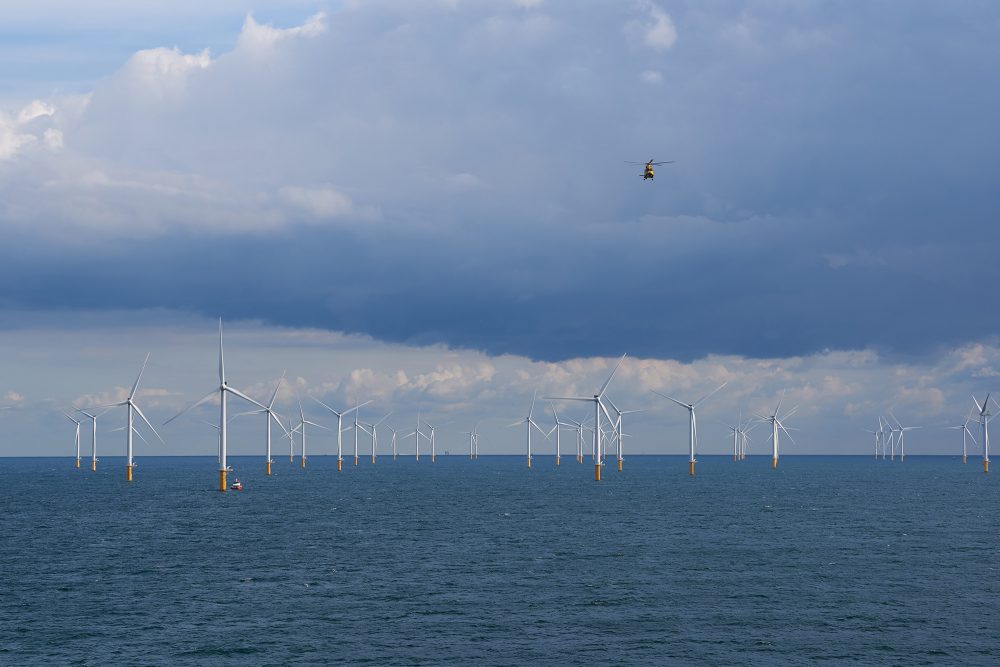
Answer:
[0,456,1000,665]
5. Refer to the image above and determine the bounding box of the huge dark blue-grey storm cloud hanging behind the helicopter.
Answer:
[0,2,1000,359]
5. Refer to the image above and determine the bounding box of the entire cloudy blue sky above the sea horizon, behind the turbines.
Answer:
[0,0,1000,455]
